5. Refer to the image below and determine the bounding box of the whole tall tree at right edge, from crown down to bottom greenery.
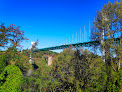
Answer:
[91,2,122,92]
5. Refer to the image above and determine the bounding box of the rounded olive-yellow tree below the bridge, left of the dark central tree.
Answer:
[51,50,74,91]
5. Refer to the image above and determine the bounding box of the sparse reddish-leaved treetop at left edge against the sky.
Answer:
[0,23,28,47]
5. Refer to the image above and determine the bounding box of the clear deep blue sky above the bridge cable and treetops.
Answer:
[0,0,119,49]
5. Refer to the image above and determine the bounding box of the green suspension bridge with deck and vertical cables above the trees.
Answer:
[35,18,121,52]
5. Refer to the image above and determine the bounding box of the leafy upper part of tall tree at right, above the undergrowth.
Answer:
[91,2,122,67]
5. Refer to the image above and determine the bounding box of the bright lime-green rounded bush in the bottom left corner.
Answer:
[0,65,22,92]
